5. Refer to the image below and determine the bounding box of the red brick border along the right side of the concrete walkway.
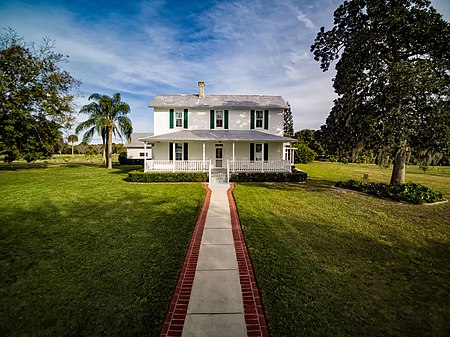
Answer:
[227,184,269,337]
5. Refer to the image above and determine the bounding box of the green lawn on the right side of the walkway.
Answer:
[234,163,450,337]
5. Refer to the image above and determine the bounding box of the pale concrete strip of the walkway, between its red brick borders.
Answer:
[182,185,247,337]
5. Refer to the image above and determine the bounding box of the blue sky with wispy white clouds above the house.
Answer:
[0,0,450,142]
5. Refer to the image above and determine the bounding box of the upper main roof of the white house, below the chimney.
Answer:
[149,95,288,109]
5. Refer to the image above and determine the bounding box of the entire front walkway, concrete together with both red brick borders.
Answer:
[160,183,269,337]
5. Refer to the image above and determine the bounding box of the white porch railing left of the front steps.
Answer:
[145,160,211,172]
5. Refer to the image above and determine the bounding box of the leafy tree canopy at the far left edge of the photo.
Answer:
[0,29,78,162]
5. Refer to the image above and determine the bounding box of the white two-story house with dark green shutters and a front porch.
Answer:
[139,82,296,172]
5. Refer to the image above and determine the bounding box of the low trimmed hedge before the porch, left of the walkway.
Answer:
[126,171,208,183]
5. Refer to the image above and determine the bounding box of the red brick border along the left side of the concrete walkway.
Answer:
[159,184,211,337]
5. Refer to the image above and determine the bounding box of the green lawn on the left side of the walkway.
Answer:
[0,160,205,336]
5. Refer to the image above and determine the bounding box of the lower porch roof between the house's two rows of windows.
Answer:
[139,130,297,143]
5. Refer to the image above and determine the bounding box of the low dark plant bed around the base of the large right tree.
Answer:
[336,179,444,204]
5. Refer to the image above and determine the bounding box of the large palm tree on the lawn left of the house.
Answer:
[76,93,133,169]
